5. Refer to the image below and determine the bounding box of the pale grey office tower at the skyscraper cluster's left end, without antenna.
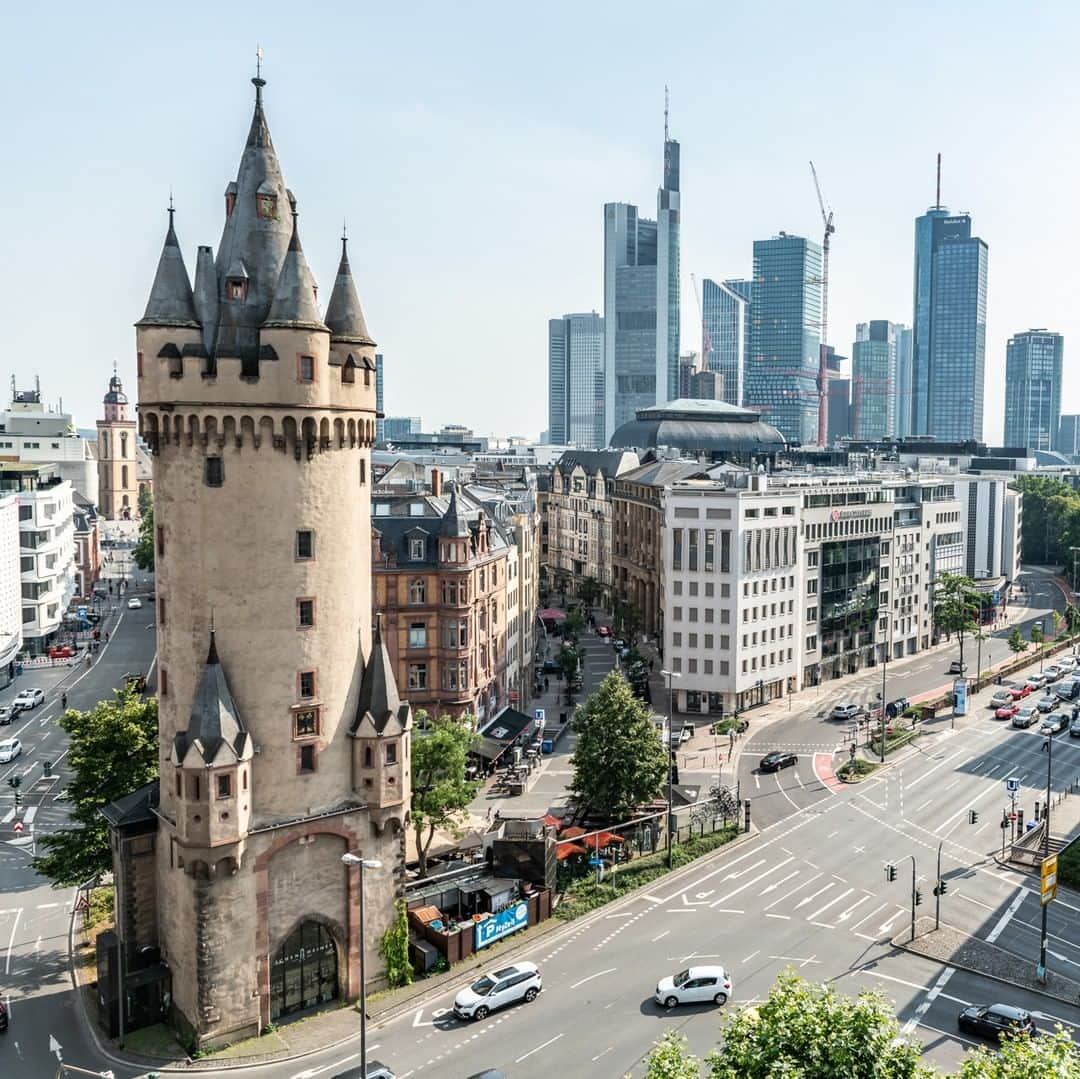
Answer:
[548,311,604,449]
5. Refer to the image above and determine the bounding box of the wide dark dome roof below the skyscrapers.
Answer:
[610,399,786,455]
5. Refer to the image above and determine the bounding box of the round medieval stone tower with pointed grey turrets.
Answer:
[136,78,411,1044]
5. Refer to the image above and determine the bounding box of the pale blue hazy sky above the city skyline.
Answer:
[0,0,1080,442]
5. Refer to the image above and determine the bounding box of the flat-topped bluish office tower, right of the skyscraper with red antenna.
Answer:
[1004,329,1065,450]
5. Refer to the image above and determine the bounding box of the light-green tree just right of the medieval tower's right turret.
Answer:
[411,714,481,877]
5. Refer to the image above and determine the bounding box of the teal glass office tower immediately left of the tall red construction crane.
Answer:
[744,232,822,445]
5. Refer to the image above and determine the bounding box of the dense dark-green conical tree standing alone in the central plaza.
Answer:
[570,671,667,820]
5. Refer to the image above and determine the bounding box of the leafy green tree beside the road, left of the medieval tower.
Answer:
[33,689,158,888]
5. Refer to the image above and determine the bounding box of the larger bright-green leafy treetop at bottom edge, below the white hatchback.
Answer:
[706,970,933,1079]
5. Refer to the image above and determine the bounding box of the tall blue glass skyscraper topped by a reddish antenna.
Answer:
[912,204,988,441]
